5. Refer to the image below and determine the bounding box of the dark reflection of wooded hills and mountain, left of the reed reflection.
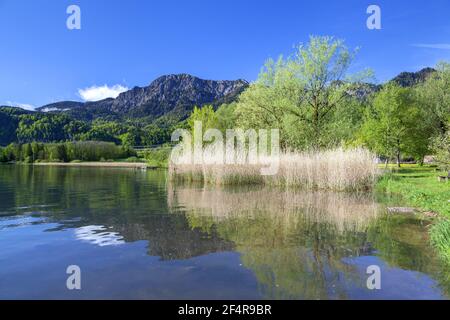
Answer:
[0,166,232,260]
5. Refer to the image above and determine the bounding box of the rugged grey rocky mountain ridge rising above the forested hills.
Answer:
[36,74,249,122]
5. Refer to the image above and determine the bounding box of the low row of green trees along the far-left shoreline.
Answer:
[0,141,136,163]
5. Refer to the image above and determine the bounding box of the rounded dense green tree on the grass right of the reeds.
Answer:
[360,83,430,167]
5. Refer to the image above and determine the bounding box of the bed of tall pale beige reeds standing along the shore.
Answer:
[169,148,378,190]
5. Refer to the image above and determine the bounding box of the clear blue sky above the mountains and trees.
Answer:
[0,0,450,106]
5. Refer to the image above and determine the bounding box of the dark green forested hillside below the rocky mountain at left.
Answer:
[0,107,182,146]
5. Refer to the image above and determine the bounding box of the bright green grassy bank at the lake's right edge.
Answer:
[377,165,450,263]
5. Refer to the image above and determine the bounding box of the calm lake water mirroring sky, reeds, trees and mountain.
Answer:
[0,166,450,299]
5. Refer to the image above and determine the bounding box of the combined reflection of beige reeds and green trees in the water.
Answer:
[168,186,450,299]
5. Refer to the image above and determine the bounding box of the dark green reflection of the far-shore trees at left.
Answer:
[0,165,165,215]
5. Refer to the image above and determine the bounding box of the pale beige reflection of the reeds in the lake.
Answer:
[168,186,380,232]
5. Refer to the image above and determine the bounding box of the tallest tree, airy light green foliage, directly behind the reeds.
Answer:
[236,37,370,149]
